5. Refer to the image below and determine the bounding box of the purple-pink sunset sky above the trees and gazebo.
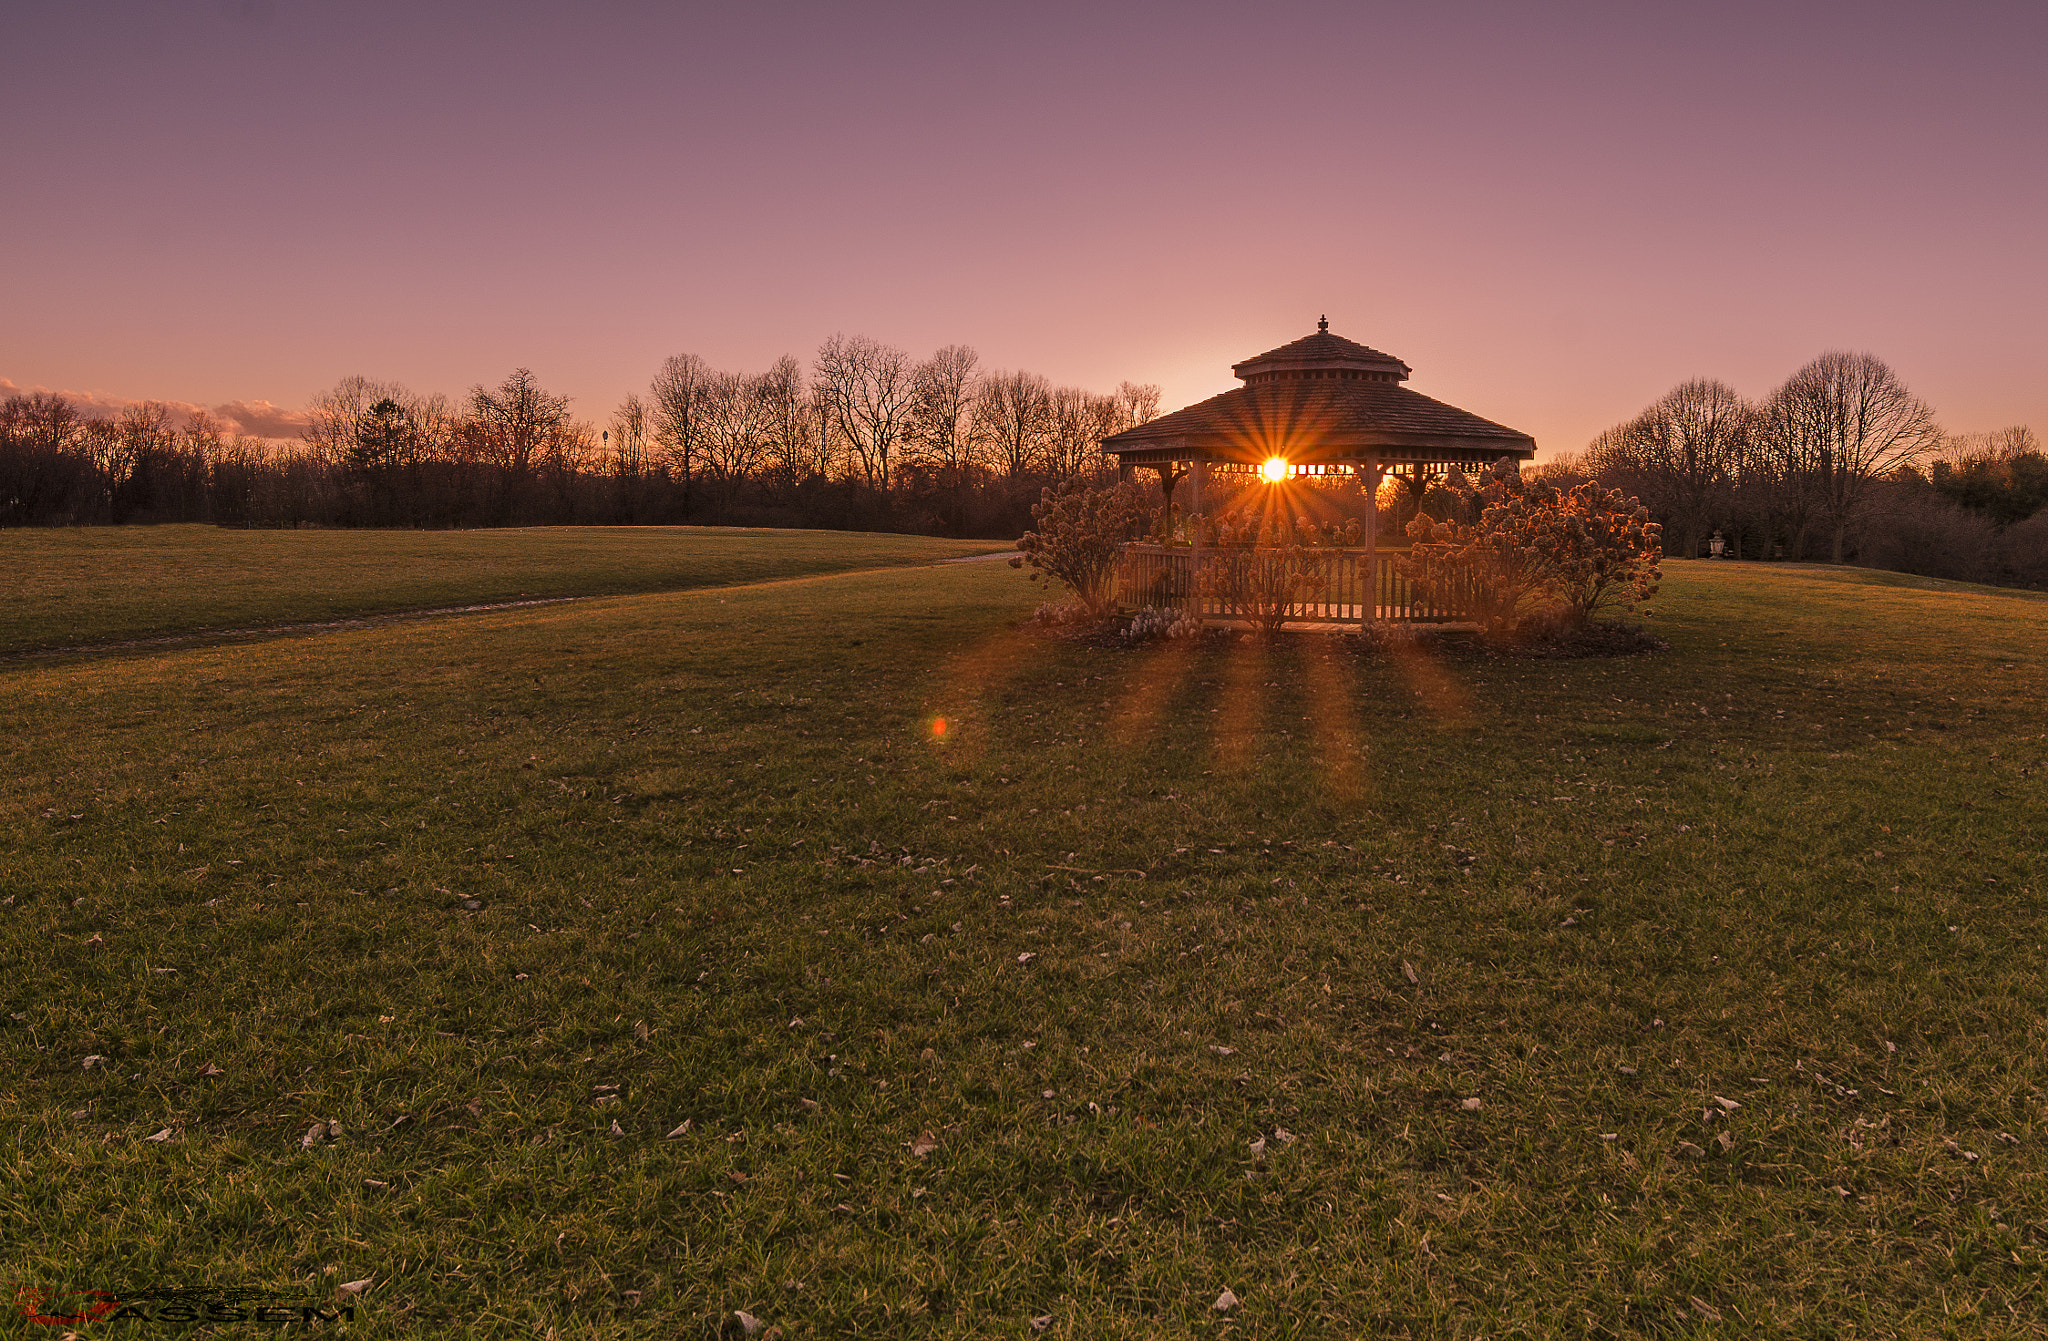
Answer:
[0,0,2048,459]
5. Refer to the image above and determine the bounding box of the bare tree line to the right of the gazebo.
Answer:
[1536,352,2048,586]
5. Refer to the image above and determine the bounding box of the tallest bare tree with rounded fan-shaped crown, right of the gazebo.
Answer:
[1767,350,1942,563]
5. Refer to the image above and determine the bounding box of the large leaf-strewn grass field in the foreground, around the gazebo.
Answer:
[0,536,2048,1339]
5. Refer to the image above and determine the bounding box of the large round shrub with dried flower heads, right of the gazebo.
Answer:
[1399,469,1663,637]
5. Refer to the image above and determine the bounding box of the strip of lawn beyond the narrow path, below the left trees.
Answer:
[0,526,1006,653]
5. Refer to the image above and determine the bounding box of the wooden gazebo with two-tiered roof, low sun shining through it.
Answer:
[1102,317,1536,622]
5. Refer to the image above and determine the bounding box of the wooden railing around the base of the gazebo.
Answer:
[1116,543,1473,624]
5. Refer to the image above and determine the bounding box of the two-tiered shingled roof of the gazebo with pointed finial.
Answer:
[1102,321,1536,465]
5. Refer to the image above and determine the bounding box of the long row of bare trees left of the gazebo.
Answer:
[0,336,1159,536]
